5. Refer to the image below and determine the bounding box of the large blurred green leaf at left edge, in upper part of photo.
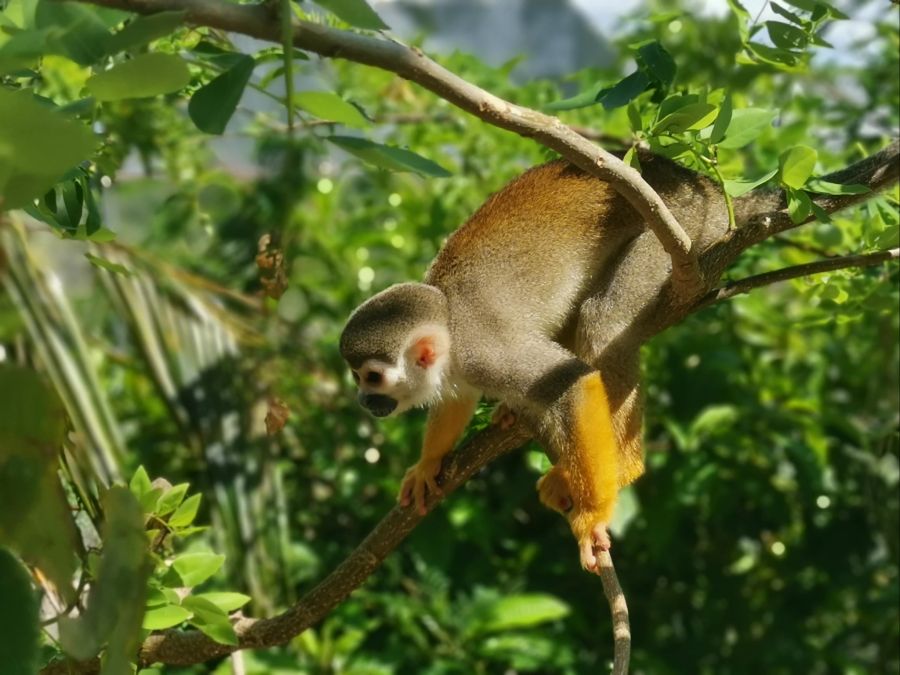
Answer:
[0,88,96,209]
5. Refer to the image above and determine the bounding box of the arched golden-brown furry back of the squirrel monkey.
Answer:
[426,160,640,332]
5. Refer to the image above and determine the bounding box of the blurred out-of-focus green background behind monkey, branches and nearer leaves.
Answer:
[0,2,900,675]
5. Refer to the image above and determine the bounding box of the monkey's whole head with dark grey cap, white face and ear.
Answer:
[340,283,450,417]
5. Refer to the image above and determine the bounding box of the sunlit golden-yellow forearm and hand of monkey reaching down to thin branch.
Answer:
[559,373,619,570]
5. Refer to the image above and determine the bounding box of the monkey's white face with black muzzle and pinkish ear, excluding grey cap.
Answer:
[351,326,450,417]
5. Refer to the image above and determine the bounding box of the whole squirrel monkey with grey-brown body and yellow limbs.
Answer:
[340,156,727,570]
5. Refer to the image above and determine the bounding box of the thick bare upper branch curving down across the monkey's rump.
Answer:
[70,0,703,300]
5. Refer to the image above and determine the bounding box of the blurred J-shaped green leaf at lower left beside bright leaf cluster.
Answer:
[59,486,153,675]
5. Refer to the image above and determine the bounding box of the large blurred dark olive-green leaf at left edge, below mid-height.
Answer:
[0,365,76,600]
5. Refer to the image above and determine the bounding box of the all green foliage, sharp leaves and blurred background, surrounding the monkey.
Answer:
[0,0,900,674]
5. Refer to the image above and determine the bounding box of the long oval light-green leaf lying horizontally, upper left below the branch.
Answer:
[87,52,191,101]
